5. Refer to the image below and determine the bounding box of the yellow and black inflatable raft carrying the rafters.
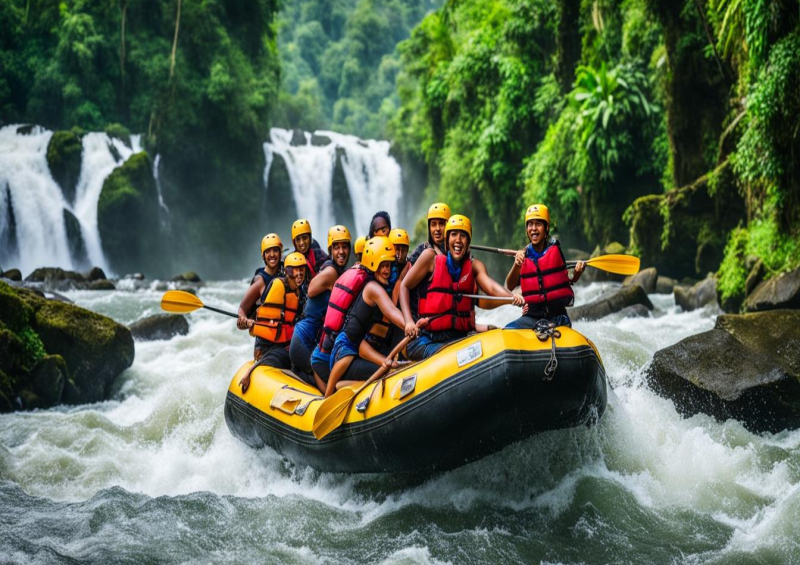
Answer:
[225,327,606,473]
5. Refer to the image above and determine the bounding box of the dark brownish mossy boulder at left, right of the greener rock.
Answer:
[34,300,134,403]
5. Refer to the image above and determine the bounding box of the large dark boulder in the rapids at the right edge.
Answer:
[647,310,800,432]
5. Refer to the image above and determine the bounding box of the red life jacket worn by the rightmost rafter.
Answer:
[519,243,575,308]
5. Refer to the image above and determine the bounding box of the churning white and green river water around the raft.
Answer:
[0,281,800,564]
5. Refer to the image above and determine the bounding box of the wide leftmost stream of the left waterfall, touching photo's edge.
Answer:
[0,125,72,273]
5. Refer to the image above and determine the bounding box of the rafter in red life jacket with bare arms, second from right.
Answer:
[400,214,524,360]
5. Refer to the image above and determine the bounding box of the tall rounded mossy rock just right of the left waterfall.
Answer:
[97,152,161,273]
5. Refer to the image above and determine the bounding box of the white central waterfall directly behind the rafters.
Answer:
[264,128,402,235]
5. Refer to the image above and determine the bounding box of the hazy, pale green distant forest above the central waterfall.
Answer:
[275,0,440,137]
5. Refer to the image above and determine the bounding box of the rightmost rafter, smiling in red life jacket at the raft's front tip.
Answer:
[506,204,586,329]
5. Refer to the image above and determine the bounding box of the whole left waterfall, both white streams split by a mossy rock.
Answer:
[0,125,142,274]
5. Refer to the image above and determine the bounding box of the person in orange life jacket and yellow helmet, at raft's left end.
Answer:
[236,252,314,393]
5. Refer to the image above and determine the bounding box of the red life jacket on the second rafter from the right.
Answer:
[419,255,478,332]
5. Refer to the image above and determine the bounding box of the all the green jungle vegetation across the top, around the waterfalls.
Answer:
[0,0,800,309]
